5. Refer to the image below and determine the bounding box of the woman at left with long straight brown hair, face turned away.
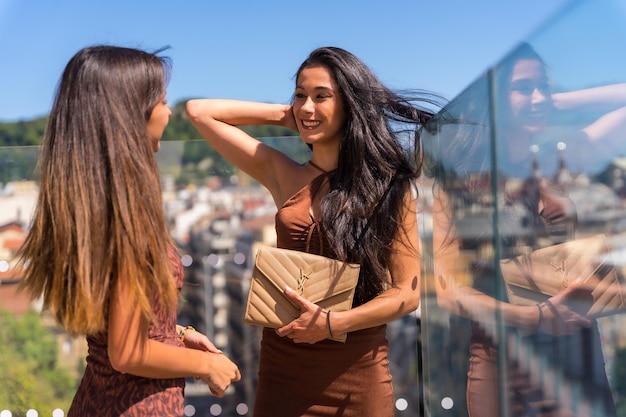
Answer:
[20,45,240,417]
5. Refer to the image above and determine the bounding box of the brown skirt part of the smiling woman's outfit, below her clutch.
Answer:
[254,326,394,417]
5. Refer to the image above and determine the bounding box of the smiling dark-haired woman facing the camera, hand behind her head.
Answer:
[187,47,438,417]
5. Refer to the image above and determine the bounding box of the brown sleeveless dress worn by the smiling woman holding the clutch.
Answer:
[254,174,394,417]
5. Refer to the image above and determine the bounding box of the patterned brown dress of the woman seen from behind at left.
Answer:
[68,250,185,417]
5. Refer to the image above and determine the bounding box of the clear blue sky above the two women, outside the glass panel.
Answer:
[0,0,570,121]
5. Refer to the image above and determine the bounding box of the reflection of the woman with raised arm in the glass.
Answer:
[433,44,626,417]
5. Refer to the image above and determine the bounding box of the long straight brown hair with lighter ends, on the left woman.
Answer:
[20,45,177,334]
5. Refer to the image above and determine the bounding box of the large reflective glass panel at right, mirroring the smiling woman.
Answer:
[422,1,626,417]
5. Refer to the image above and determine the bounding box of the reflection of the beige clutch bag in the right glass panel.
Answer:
[500,234,625,318]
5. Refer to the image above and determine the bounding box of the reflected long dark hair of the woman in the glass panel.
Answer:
[424,42,547,252]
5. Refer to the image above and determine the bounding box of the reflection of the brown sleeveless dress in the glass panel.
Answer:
[467,184,616,417]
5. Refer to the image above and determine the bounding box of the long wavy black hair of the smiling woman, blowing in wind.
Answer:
[296,47,439,305]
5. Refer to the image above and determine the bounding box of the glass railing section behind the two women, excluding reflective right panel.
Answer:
[0,137,420,416]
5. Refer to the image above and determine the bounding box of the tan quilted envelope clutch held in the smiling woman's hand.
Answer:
[243,245,360,342]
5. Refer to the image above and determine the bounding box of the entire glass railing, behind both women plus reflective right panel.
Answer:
[0,0,626,417]
